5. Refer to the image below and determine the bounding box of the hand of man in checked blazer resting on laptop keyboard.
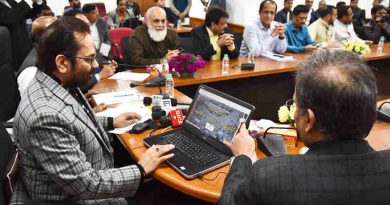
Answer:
[138,144,175,175]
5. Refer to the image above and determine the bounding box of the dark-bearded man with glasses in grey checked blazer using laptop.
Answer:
[11,17,174,204]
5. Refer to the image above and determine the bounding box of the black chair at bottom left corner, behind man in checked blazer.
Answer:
[0,123,16,204]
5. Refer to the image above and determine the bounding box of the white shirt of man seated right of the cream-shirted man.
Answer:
[334,19,363,43]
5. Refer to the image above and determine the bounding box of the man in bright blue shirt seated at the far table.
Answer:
[286,5,317,53]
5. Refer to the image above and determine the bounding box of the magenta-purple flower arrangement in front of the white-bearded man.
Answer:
[168,53,206,75]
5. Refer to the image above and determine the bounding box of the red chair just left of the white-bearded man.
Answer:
[110,28,133,62]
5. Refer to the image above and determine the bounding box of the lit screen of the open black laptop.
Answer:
[187,89,251,144]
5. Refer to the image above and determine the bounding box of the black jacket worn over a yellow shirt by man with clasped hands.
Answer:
[191,24,241,60]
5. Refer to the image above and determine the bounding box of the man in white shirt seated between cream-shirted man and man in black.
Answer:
[334,5,363,43]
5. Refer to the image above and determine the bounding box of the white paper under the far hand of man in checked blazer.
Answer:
[96,101,152,134]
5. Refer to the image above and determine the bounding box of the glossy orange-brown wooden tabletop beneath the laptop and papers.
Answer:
[94,75,390,203]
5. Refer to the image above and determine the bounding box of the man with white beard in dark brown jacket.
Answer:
[129,7,179,66]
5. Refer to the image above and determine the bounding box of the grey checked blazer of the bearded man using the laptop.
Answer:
[11,71,141,204]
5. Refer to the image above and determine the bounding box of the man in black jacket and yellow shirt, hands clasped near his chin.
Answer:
[191,7,238,60]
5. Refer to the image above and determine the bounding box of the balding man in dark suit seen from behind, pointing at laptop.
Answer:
[219,50,390,205]
